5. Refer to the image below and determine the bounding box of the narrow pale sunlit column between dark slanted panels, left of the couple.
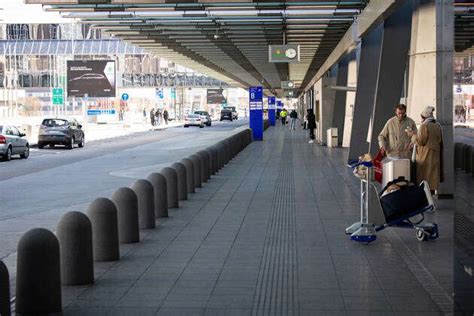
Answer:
[339,52,357,147]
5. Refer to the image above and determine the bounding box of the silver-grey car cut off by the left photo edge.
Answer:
[0,125,30,161]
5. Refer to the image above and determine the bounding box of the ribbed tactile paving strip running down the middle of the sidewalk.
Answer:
[252,148,298,315]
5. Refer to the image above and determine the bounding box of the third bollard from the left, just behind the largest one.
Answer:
[56,212,94,285]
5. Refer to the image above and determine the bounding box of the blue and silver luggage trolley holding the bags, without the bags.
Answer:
[345,161,439,244]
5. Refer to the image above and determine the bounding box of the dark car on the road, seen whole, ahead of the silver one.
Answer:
[38,118,85,149]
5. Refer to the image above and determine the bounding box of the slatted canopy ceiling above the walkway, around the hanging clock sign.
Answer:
[26,0,368,96]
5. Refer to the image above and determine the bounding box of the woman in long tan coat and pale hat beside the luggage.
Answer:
[407,106,443,191]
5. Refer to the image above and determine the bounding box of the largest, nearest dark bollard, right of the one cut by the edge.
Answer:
[15,228,62,315]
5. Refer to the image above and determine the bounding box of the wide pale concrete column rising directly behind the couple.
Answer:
[408,0,454,197]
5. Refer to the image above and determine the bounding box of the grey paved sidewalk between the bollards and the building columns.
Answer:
[51,128,453,315]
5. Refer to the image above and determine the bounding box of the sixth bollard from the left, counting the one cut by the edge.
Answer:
[131,179,156,229]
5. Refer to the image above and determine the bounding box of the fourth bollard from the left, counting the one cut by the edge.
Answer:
[87,198,120,262]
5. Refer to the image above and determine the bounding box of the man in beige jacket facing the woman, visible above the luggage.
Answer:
[378,104,416,159]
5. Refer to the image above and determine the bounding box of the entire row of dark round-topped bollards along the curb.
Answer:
[0,129,252,316]
